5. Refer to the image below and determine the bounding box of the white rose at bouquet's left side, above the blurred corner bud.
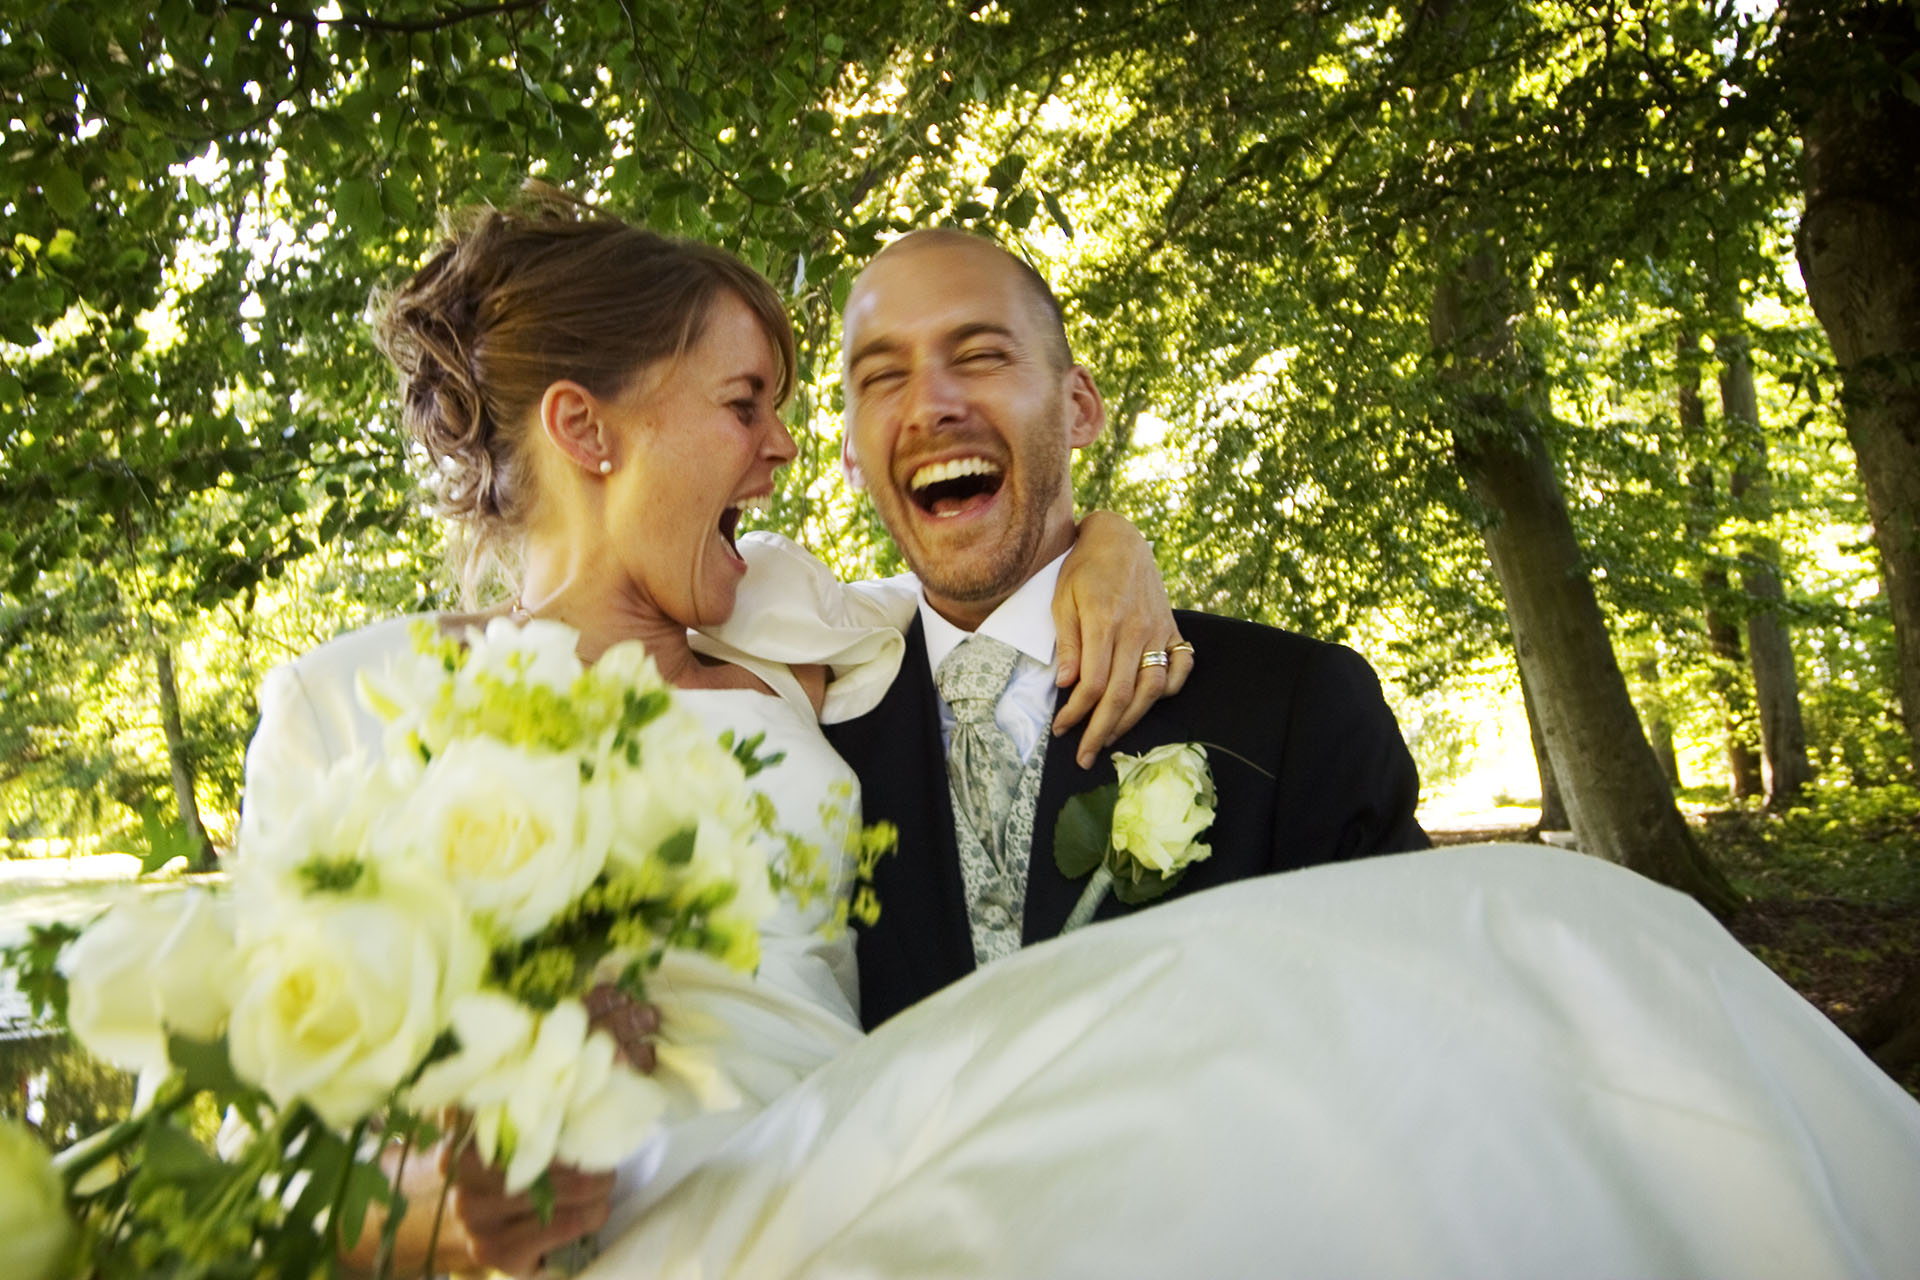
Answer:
[60,889,234,1071]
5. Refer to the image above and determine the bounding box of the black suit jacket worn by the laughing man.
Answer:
[828,612,1427,1027]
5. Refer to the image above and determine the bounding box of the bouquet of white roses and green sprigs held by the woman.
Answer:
[15,620,826,1276]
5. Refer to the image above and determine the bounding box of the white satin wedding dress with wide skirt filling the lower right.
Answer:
[242,541,1920,1280]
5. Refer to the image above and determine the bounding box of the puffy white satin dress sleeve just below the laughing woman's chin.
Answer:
[695,533,920,723]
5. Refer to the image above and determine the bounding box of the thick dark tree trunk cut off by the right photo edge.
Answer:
[1784,0,1920,773]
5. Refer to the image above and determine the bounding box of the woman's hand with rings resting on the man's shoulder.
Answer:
[1054,510,1194,768]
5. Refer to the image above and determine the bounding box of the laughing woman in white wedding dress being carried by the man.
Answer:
[242,192,1920,1278]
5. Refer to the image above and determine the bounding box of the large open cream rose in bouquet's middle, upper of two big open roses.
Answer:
[376,737,614,938]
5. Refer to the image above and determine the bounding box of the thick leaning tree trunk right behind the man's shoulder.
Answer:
[1430,246,1736,913]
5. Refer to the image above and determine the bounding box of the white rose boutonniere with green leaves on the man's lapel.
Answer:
[1054,743,1213,933]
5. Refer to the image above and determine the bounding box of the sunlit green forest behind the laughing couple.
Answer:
[0,0,1920,1065]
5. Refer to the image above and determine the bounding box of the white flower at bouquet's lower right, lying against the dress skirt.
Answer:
[407,992,666,1192]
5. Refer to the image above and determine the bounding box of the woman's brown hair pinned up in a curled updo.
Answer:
[374,182,793,601]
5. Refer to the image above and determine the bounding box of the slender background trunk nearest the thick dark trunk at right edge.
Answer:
[1715,326,1812,810]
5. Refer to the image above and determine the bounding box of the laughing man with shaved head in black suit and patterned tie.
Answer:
[828,230,1427,1027]
